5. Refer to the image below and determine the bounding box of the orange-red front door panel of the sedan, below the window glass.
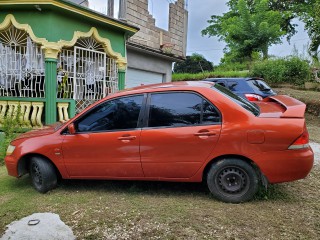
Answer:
[62,129,143,178]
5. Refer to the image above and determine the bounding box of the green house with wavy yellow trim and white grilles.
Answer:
[0,0,139,127]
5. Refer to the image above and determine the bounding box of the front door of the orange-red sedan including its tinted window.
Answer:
[62,95,144,178]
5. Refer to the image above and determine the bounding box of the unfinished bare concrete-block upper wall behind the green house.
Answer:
[126,0,188,57]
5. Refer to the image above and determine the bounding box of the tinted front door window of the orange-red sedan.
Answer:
[75,95,143,132]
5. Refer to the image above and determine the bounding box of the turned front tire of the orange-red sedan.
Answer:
[29,157,58,193]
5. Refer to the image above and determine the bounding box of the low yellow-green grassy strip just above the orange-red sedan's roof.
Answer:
[172,71,249,82]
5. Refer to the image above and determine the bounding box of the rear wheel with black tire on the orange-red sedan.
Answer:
[206,159,259,203]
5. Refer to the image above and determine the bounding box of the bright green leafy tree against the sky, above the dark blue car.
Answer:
[202,0,289,60]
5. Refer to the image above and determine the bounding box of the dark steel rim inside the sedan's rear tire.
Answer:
[216,167,250,196]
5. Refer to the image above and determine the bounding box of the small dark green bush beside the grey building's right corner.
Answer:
[173,53,213,73]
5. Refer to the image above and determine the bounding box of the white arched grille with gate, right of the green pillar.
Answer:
[57,37,118,113]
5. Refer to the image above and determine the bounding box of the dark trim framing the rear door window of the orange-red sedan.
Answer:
[142,90,222,129]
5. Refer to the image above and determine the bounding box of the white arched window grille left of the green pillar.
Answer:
[0,26,45,98]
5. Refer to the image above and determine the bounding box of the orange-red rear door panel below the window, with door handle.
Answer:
[140,125,221,178]
